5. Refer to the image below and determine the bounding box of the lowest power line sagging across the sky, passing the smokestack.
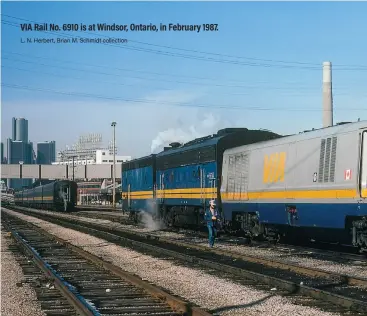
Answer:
[1,83,367,112]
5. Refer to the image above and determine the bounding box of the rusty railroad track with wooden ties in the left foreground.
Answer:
[1,212,210,316]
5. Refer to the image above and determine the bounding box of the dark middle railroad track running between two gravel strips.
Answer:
[2,206,367,315]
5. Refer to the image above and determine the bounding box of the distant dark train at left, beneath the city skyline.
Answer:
[14,180,78,212]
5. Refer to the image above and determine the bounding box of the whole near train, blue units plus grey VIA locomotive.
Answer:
[121,121,367,252]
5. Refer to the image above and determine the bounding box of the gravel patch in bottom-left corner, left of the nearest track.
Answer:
[1,227,46,316]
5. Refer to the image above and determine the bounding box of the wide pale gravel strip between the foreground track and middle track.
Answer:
[4,210,339,316]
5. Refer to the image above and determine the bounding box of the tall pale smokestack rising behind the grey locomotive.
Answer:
[322,61,333,127]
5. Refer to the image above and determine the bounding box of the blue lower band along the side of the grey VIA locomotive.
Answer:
[222,201,367,229]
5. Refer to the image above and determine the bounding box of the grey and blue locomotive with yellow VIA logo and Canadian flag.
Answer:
[221,121,367,248]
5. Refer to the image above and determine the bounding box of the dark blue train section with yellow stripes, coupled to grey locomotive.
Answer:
[121,128,280,226]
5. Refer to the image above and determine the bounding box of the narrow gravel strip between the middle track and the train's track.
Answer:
[14,210,367,278]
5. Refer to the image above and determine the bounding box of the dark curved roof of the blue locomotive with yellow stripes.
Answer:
[156,128,281,159]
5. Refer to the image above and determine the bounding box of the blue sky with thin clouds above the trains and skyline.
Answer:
[1,1,367,157]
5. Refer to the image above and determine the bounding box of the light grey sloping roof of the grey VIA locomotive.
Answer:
[226,120,367,153]
